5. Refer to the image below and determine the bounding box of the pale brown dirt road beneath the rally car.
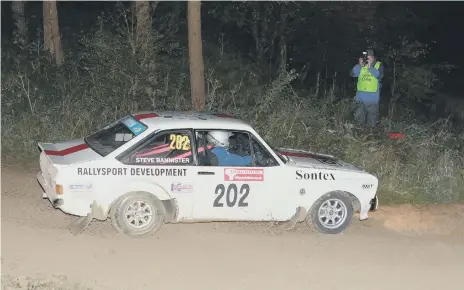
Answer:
[1,168,464,290]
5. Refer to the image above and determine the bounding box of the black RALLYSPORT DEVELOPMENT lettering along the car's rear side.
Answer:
[77,167,187,176]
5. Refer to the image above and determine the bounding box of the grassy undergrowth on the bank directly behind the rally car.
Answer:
[1,18,464,203]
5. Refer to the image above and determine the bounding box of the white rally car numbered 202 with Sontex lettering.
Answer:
[37,111,378,236]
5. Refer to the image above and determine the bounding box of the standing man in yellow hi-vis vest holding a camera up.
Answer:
[350,49,383,127]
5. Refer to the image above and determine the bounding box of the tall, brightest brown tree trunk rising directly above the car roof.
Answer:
[188,0,205,111]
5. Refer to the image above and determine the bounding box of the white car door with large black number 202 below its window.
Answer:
[193,130,280,221]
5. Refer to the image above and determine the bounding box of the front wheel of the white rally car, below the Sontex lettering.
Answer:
[306,191,354,234]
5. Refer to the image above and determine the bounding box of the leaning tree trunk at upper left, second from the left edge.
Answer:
[43,1,63,66]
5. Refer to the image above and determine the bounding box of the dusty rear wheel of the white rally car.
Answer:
[111,192,166,237]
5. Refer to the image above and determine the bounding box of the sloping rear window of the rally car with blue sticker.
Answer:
[85,116,147,156]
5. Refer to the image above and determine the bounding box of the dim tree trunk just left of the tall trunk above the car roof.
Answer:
[134,1,152,51]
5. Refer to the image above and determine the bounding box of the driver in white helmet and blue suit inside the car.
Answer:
[206,131,253,166]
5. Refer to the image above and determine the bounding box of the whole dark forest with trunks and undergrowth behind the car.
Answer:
[1,1,464,203]
